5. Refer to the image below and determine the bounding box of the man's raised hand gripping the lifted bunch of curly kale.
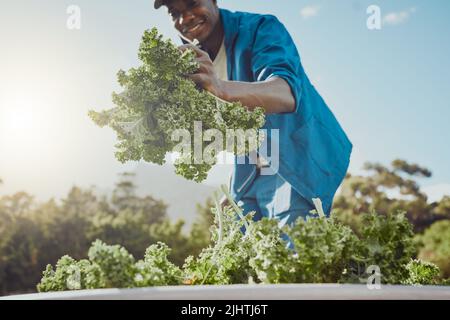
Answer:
[178,44,223,97]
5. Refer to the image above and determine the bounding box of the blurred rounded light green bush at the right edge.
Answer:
[417,220,450,278]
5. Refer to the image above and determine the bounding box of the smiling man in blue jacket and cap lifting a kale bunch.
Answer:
[155,0,352,235]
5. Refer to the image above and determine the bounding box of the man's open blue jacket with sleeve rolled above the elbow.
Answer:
[220,9,352,213]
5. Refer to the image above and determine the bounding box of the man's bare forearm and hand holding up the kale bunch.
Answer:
[180,44,295,113]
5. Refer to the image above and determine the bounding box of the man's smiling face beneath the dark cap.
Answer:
[165,0,219,43]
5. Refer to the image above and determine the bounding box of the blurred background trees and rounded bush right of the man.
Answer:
[333,159,450,278]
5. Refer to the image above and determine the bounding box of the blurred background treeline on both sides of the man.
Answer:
[0,160,450,295]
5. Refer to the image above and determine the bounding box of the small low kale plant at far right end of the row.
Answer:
[403,259,440,285]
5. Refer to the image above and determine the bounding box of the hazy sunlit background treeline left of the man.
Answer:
[0,173,213,295]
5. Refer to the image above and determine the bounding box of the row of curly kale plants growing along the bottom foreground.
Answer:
[38,190,443,291]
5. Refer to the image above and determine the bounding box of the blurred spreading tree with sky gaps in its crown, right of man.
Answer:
[333,159,450,232]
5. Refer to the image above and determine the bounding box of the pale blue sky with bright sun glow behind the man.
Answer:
[0,0,450,199]
